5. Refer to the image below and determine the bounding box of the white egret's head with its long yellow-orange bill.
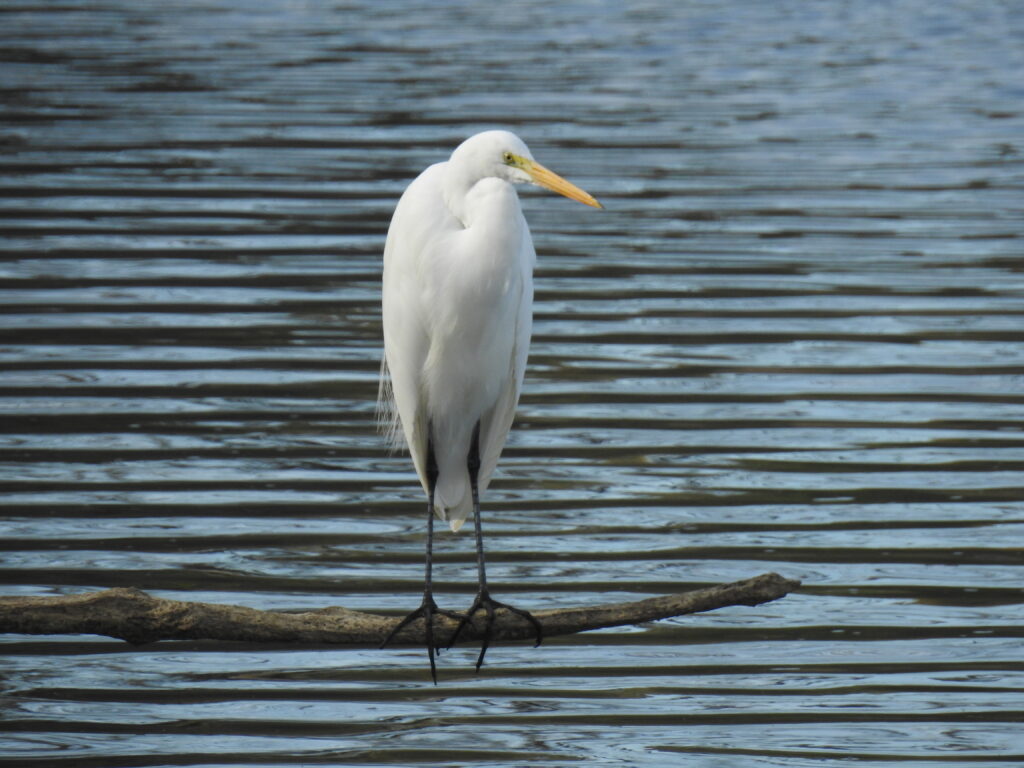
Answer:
[452,131,603,208]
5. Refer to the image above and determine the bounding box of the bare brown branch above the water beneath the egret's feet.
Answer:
[0,573,800,645]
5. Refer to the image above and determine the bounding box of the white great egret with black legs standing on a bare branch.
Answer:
[378,131,601,682]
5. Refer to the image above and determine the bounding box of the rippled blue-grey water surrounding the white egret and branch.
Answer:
[0,0,1024,768]
